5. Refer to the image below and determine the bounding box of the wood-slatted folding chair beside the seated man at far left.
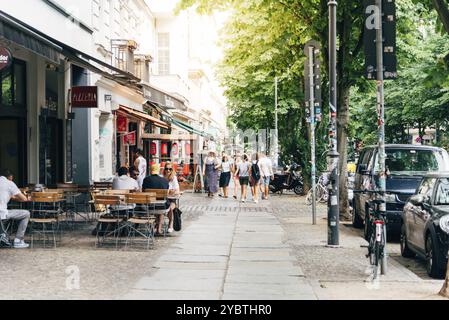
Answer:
[30,192,64,248]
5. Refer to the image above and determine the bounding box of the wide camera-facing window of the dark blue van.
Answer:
[375,149,445,173]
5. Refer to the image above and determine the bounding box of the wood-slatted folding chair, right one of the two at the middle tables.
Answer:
[125,193,156,250]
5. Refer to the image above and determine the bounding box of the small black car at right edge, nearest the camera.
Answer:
[401,173,449,278]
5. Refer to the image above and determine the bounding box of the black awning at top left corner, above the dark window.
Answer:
[0,11,62,64]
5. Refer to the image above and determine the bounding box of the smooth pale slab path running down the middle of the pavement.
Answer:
[124,194,316,300]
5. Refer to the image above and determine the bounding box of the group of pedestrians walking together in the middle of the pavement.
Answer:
[203,151,274,203]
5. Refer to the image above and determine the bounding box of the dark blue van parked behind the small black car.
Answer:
[352,144,449,237]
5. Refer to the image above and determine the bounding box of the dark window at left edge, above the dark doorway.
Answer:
[0,59,26,107]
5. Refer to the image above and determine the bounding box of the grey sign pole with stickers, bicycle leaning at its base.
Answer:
[376,0,387,274]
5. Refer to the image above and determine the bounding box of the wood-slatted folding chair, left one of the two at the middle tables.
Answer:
[93,195,124,248]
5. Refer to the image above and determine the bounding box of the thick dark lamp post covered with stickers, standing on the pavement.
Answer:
[327,0,340,246]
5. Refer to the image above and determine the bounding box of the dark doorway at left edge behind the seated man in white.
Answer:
[0,118,28,186]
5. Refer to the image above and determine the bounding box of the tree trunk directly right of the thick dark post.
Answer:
[337,85,350,219]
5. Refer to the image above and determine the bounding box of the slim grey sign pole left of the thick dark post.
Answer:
[309,46,316,225]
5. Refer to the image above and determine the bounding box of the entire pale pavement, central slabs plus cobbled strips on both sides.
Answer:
[0,193,442,300]
